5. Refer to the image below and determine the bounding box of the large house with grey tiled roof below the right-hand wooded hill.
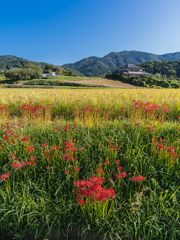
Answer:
[116,64,153,77]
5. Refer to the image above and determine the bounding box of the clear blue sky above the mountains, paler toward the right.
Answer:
[0,0,180,65]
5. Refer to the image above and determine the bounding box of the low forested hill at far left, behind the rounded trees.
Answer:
[0,55,47,70]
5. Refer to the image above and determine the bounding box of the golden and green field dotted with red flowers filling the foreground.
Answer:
[0,89,180,240]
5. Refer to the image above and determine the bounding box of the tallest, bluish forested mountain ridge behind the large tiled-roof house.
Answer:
[62,51,180,76]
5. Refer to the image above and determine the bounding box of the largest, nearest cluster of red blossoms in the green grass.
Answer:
[74,176,116,205]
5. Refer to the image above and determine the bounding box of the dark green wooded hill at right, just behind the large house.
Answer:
[138,60,180,78]
